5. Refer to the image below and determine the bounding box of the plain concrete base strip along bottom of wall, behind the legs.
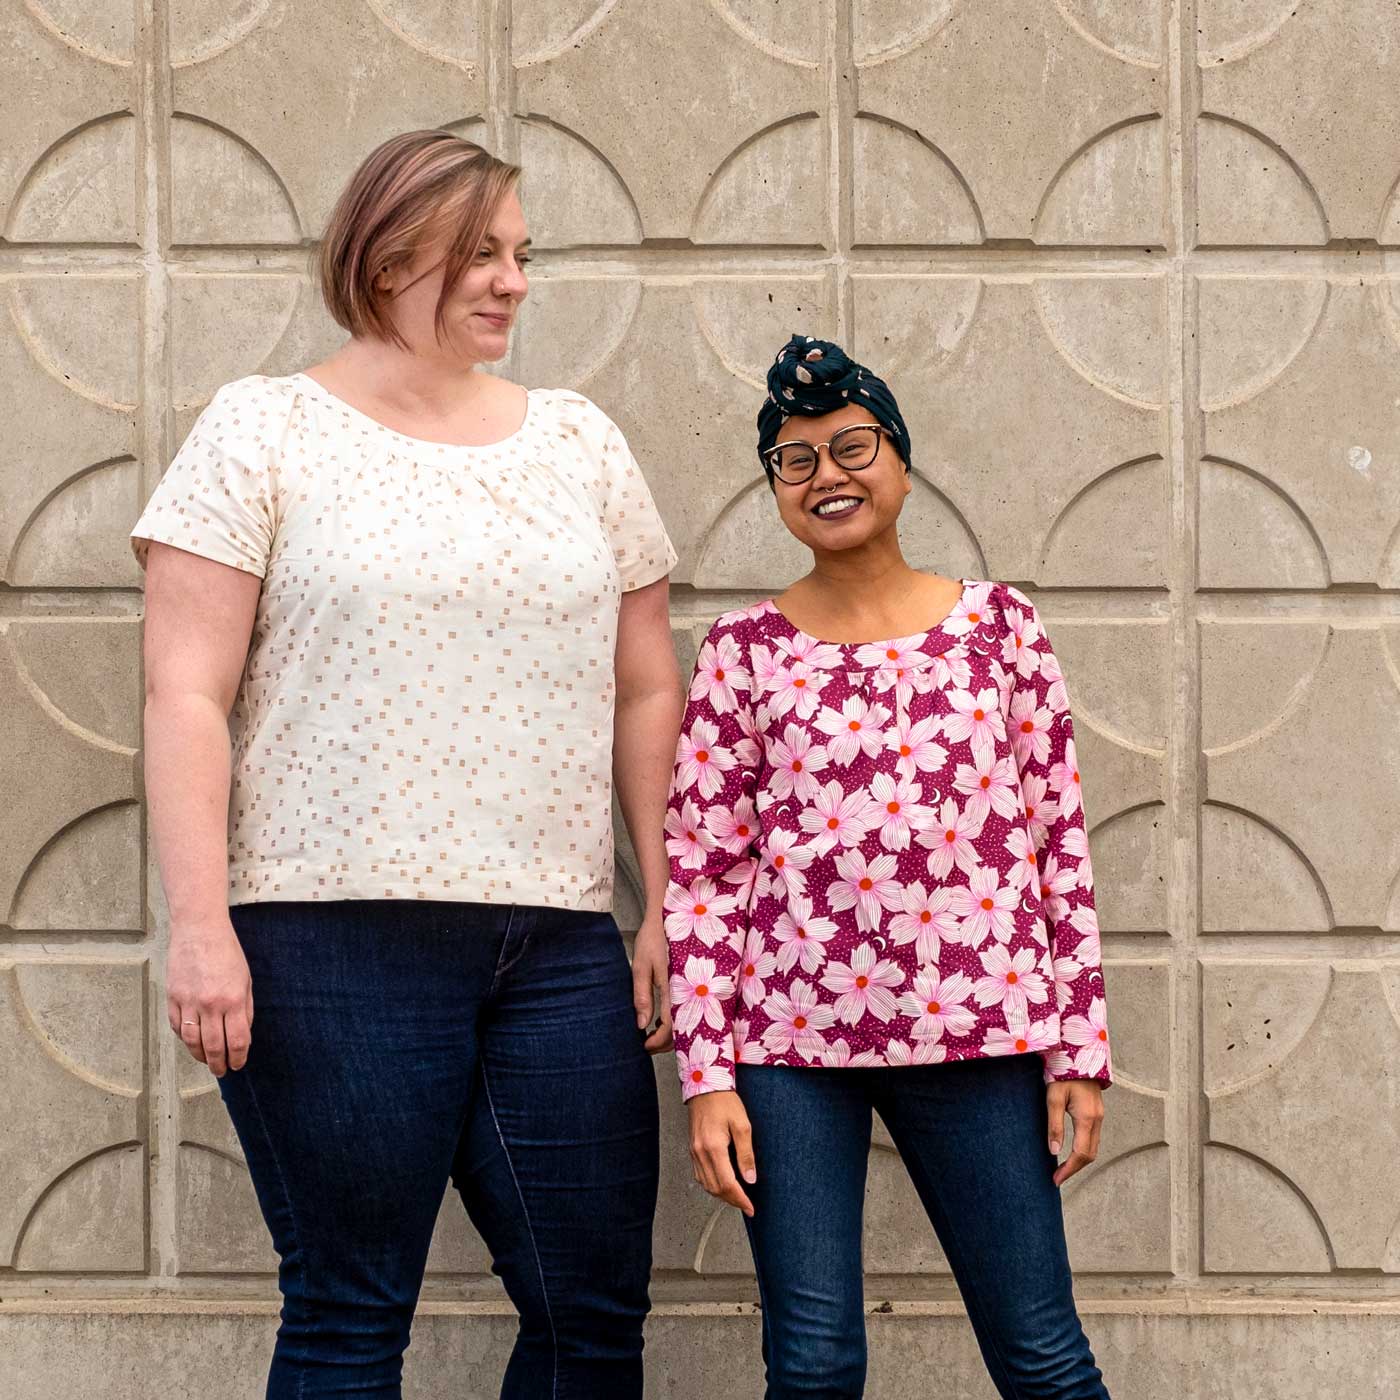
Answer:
[13,1298,1400,1400]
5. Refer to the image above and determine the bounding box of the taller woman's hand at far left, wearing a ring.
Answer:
[165,914,253,1078]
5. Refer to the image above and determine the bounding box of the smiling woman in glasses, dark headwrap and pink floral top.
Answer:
[666,336,1110,1400]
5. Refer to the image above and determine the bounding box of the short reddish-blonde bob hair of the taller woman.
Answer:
[319,132,521,349]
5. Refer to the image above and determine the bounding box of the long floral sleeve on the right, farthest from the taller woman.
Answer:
[1002,587,1112,1086]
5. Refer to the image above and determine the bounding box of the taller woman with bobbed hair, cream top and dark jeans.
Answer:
[133,132,682,1400]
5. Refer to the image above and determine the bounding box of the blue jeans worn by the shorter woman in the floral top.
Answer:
[738,1054,1107,1400]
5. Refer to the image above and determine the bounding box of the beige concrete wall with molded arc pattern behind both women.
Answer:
[0,0,1400,1400]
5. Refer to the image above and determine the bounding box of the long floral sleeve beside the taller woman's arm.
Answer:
[665,613,762,1099]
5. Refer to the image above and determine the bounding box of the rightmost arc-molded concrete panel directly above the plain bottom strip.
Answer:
[1204,959,1400,1271]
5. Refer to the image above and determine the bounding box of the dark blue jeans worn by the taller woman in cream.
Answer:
[220,900,658,1400]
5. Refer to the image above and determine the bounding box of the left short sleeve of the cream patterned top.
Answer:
[132,379,286,578]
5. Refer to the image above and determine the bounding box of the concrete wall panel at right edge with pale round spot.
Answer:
[1200,279,1400,587]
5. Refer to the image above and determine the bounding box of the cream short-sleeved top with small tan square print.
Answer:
[132,374,676,910]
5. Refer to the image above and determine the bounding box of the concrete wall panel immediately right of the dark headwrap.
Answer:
[853,276,1168,585]
